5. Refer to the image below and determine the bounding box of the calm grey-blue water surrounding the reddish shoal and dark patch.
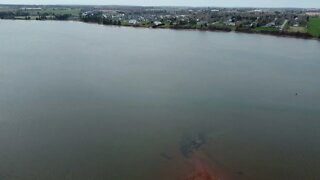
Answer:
[0,21,320,180]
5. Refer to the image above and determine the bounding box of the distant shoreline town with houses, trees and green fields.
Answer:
[0,5,320,39]
